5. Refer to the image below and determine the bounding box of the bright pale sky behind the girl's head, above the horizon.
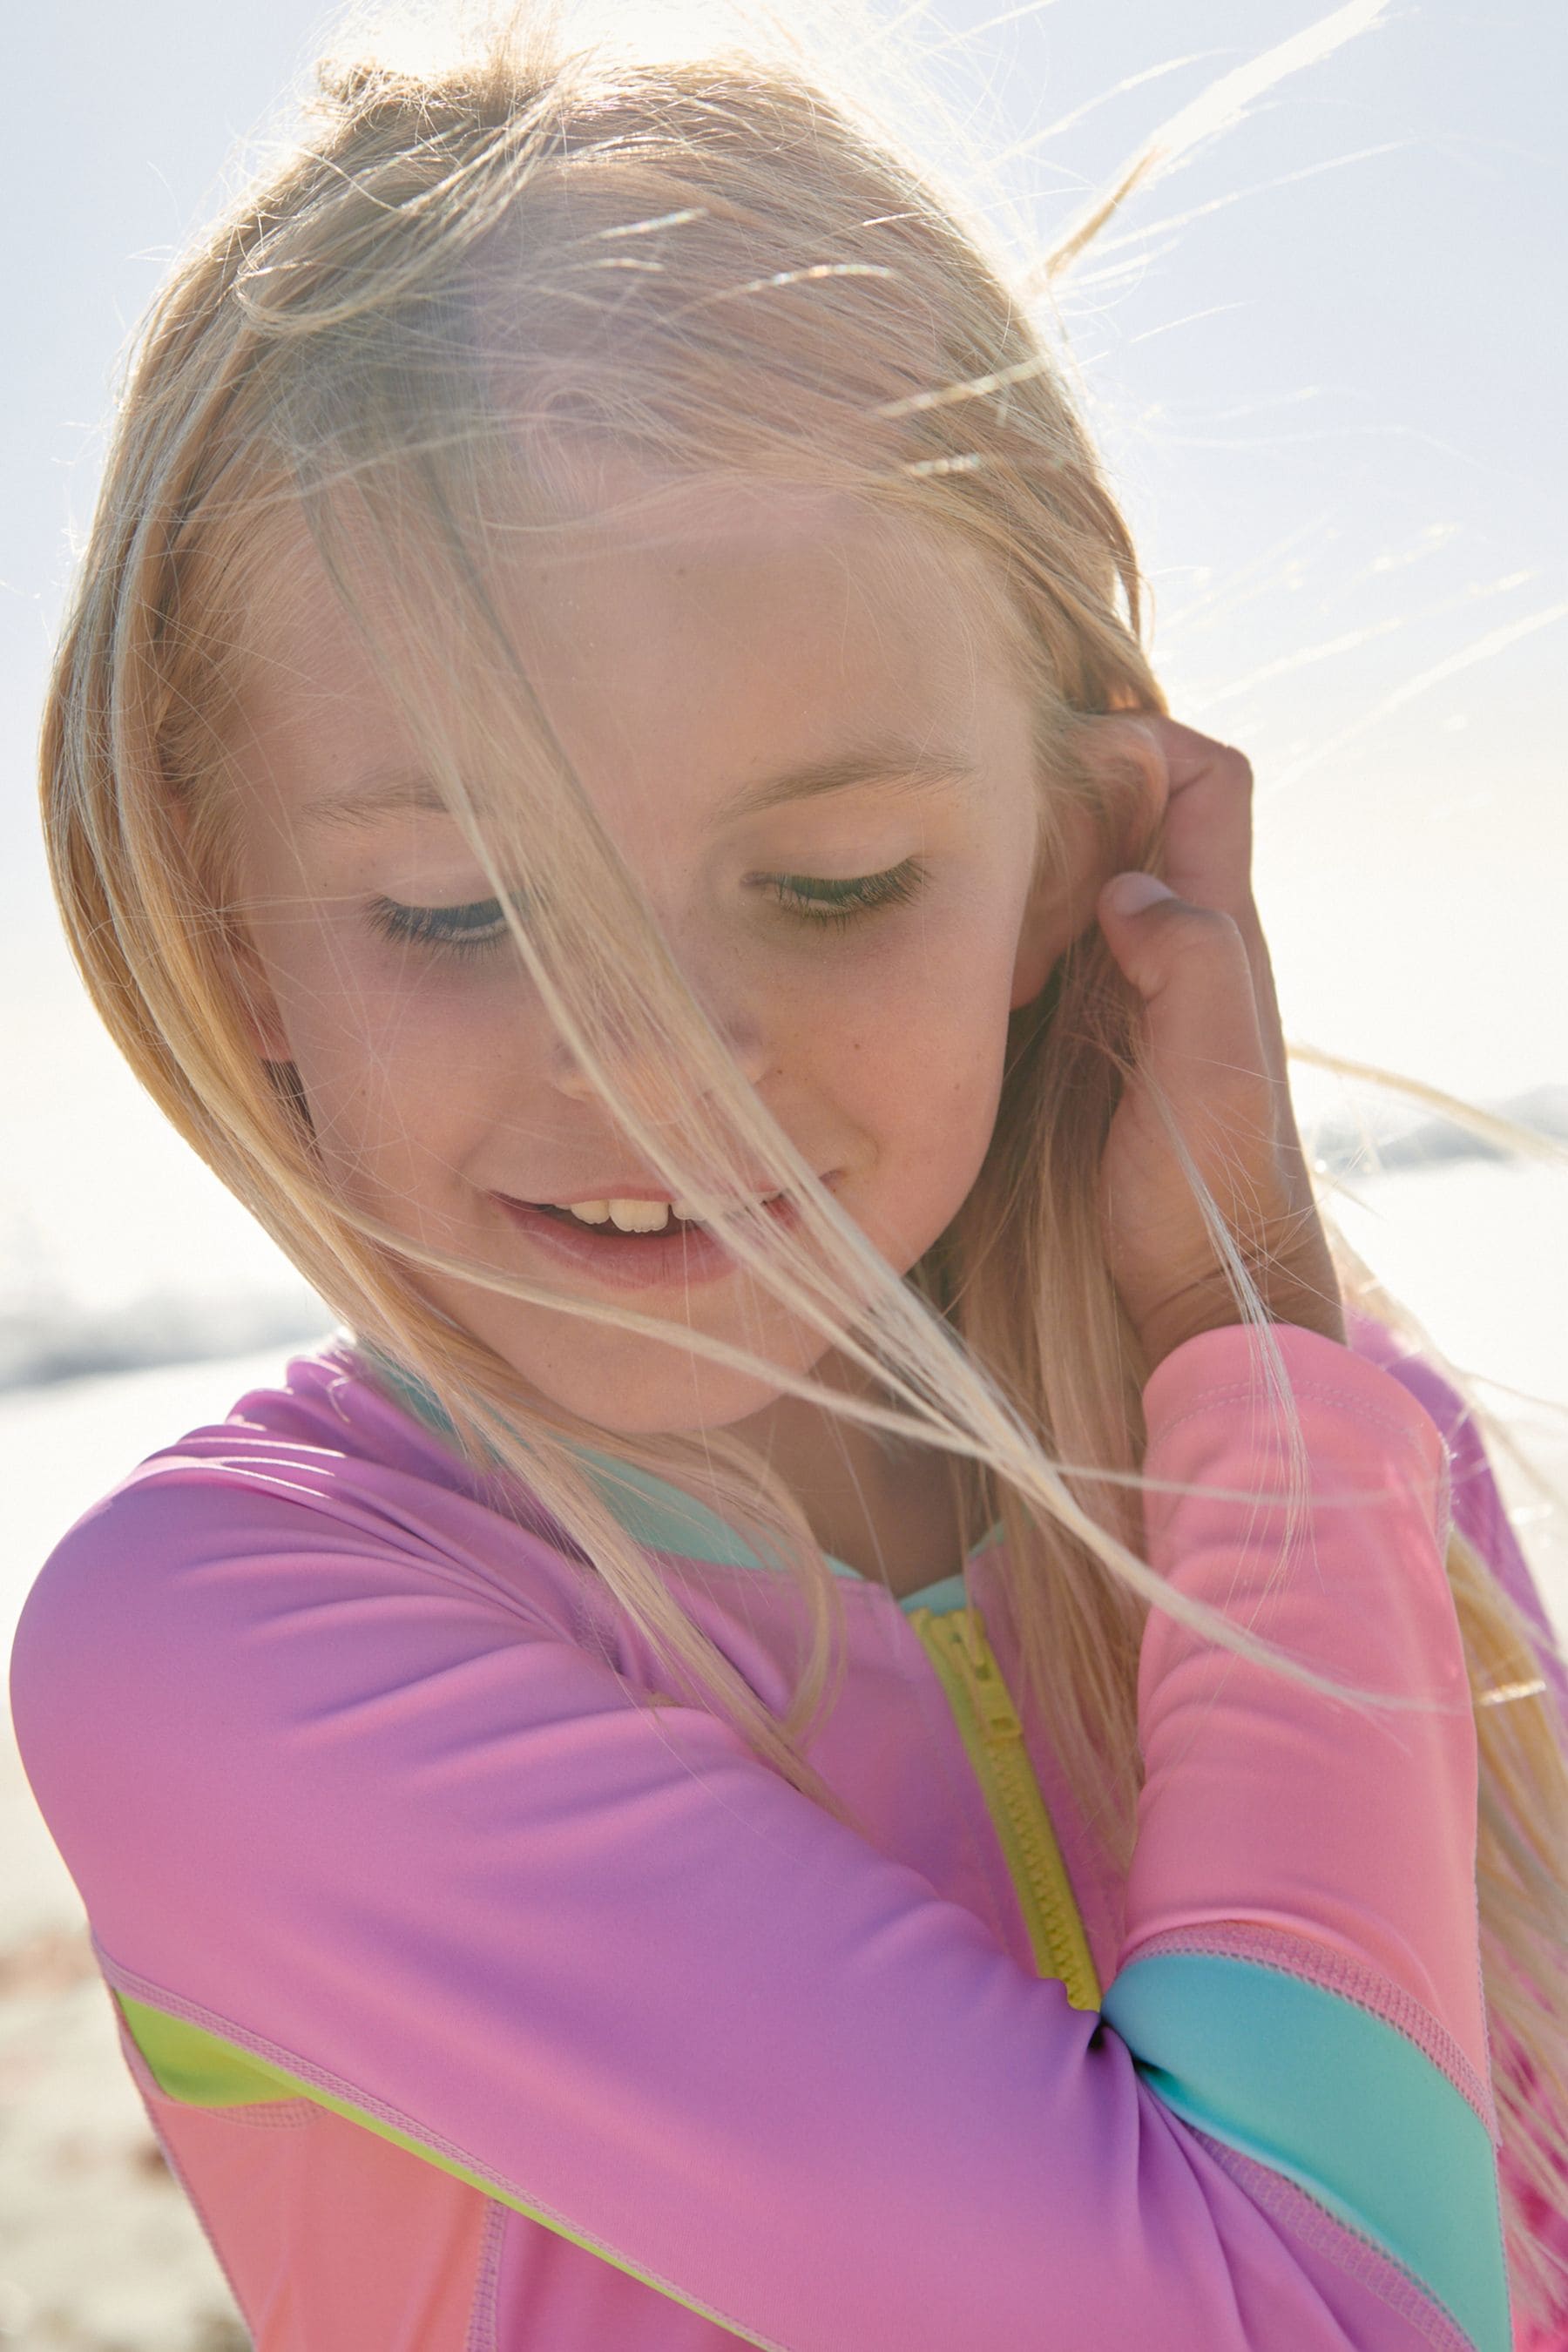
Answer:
[0,0,1568,1317]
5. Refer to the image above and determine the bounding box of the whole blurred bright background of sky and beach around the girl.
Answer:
[0,0,1568,2352]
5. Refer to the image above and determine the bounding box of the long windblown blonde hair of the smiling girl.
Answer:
[43,9,1568,2319]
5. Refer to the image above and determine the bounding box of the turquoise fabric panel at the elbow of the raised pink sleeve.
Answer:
[1103,1952,1511,2352]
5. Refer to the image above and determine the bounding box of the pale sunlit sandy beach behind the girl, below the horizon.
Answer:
[0,1308,1568,2352]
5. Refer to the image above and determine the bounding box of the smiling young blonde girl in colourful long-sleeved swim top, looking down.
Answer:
[11,9,1568,2352]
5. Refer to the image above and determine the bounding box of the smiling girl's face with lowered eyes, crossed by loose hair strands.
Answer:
[230,484,1112,1435]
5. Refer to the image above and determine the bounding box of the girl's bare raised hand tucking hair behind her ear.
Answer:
[1096,718,1345,1371]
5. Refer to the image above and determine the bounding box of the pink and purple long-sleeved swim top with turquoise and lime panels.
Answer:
[11,1324,1568,2352]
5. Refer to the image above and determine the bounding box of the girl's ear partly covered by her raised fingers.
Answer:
[1010,715,1168,1011]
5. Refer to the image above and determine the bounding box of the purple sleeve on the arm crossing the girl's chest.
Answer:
[11,1345,1457,2352]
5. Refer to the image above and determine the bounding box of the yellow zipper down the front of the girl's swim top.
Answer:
[909,1606,1100,2009]
